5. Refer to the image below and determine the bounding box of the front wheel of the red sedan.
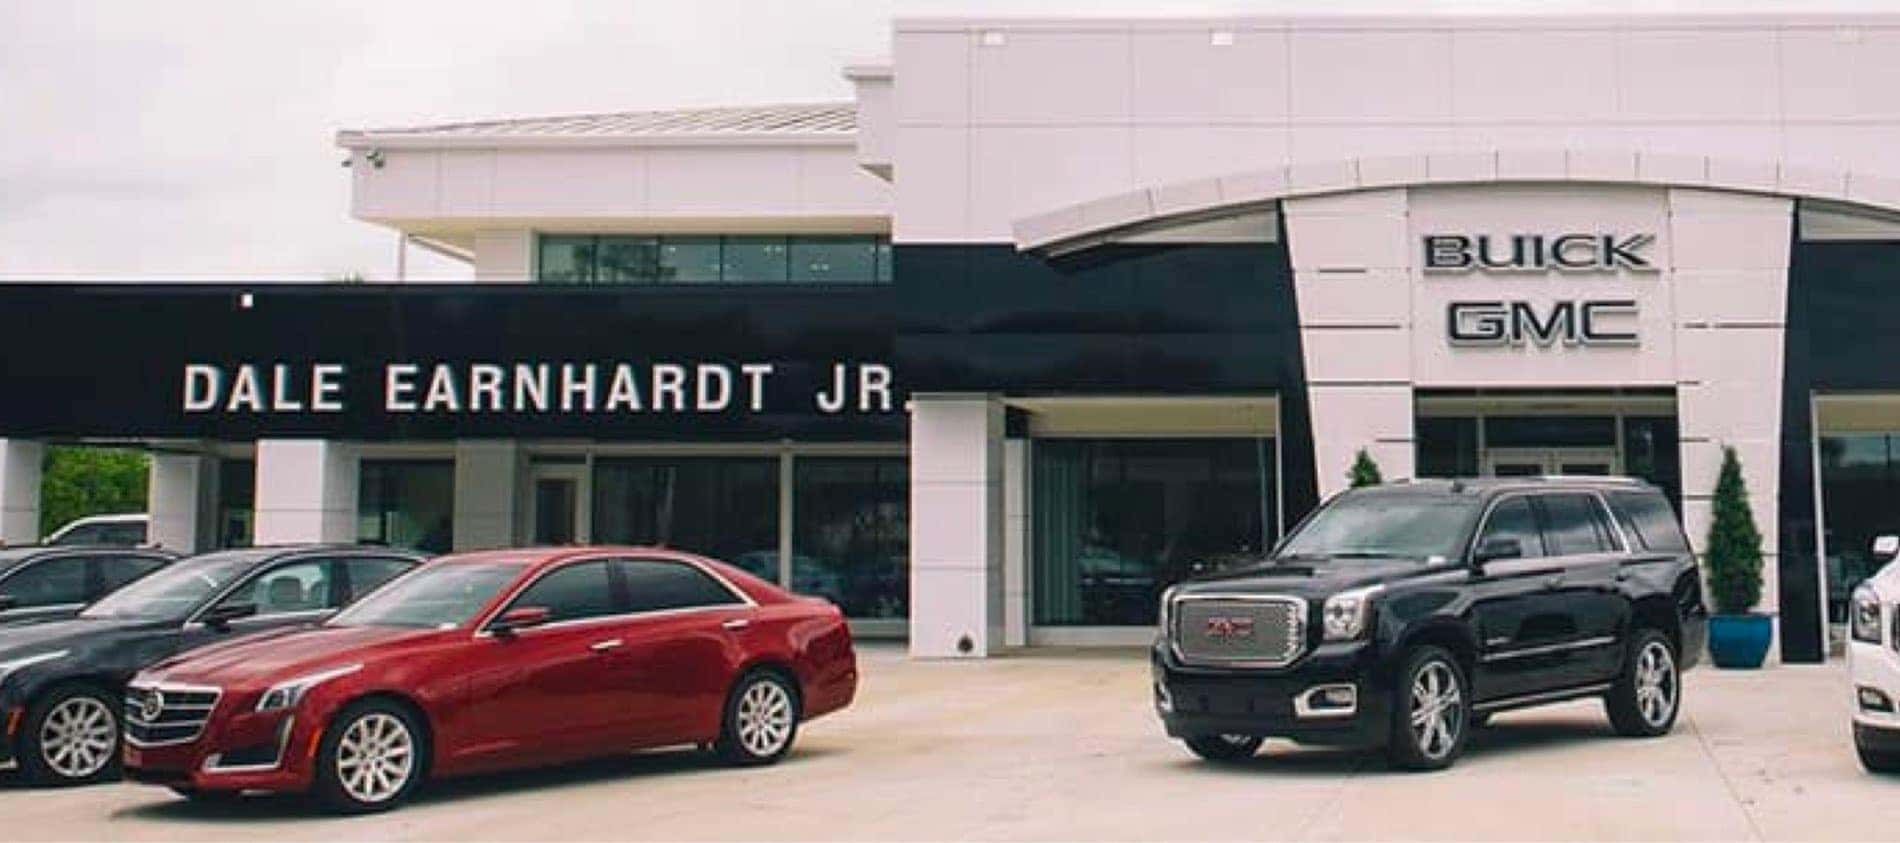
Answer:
[312,699,429,815]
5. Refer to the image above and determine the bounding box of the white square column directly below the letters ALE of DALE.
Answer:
[257,439,359,545]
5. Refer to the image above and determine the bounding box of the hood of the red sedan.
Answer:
[141,627,443,689]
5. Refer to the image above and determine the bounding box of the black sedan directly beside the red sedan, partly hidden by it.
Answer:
[0,545,422,784]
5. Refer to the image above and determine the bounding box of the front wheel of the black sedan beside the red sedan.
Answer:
[17,685,120,786]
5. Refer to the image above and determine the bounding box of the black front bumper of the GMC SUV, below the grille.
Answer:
[1151,642,1391,746]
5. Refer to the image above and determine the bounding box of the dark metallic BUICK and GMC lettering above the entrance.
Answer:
[1421,234,1661,347]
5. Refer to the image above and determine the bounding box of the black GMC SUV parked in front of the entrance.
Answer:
[1153,478,1708,769]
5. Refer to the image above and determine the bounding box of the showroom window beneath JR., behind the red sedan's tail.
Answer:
[786,458,910,619]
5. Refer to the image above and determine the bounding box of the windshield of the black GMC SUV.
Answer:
[1275,494,1478,562]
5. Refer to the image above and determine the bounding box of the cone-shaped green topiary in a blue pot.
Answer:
[1708,448,1775,670]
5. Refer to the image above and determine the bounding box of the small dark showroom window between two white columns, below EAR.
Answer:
[357,459,456,553]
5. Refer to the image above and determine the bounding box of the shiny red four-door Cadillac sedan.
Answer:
[125,547,857,813]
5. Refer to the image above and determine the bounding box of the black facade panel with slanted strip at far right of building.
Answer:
[1778,241,1900,663]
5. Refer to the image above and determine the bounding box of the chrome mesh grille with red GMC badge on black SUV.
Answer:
[1169,594,1305,666]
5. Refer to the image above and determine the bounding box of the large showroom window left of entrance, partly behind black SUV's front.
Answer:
[1030,439,1277,627]
